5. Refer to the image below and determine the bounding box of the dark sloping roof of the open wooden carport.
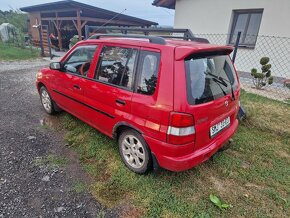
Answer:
[20,0,158,26]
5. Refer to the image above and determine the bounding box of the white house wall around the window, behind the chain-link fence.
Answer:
[175,0,290,78]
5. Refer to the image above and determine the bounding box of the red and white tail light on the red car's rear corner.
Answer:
[167,112,195,145]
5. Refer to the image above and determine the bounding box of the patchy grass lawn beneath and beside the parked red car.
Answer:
[61,92,290,217]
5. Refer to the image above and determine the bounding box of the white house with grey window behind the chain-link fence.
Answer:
[153,0,290,82]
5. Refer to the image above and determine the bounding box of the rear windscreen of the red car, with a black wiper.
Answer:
[185,53,238,105]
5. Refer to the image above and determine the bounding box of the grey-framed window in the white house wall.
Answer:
[229,9,263,47]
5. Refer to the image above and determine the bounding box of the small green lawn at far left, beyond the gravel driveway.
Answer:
[0,42,39,61]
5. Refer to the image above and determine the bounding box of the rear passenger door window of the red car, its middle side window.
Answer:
[96,46,137,89]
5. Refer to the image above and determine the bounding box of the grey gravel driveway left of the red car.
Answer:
[0,60,117,218]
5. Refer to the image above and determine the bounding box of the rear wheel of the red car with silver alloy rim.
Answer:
[118,130,152,174]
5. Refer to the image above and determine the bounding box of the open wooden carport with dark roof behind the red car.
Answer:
[20,0,158,49]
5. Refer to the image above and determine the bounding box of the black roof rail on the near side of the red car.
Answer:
[88,34,166,45]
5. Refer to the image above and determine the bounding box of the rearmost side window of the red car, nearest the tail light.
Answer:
[137,51,160,95]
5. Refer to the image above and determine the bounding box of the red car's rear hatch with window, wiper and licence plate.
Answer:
[179,50,239,149]
